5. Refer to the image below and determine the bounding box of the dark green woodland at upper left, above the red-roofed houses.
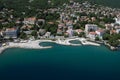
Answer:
[0,0,68,17]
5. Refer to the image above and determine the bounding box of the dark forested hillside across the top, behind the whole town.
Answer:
[0,0,120,16]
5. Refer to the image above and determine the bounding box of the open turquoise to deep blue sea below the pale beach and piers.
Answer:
[0,43,120,80]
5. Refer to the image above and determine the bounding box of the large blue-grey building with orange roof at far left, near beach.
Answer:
[4,28,19,39]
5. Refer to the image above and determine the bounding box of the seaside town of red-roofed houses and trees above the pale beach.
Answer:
[0,0,120,49]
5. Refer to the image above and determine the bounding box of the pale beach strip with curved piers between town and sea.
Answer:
[0,38,100,54]
